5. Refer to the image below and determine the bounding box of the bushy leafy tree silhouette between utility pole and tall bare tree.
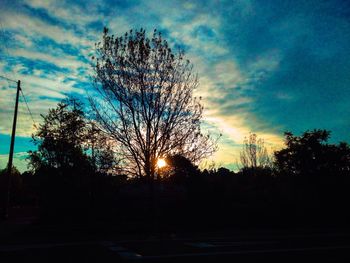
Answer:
[29,99,87,170]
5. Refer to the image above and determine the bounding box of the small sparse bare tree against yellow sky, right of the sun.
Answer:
[240,133,271,168]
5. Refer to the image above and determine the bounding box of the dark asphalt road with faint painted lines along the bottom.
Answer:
[0,229,350,263]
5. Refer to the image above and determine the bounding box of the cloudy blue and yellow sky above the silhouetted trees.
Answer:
[0,0,350,171]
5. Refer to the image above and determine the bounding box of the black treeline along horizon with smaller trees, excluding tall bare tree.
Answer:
[0,100,350,231]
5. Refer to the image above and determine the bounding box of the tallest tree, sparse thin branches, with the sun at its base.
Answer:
[90,28,217,178]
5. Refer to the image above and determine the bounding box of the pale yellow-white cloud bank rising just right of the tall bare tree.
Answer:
[157,7,282,169]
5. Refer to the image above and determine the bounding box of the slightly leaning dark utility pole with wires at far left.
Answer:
[4,80,21,219]
